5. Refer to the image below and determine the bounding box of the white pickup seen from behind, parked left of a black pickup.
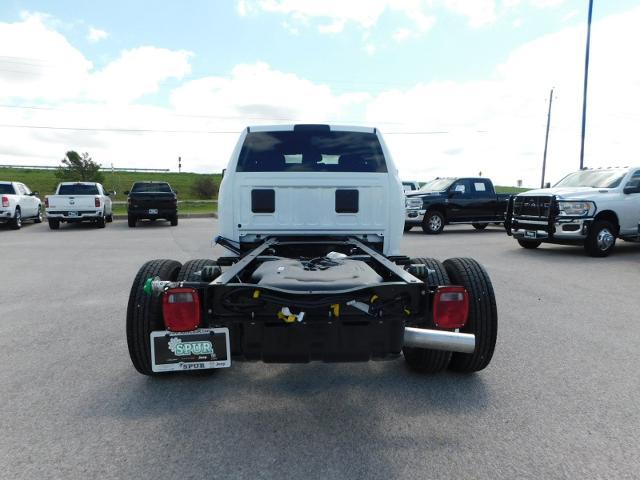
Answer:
[44,182,113,230]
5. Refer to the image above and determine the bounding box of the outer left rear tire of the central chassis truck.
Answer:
[127,260,181,375]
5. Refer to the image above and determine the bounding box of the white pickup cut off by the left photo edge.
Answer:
[0,181,42,230]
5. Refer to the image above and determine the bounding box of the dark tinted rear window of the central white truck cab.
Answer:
[236,130,387,172]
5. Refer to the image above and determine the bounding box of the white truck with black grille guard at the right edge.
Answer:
[505,167,640,257]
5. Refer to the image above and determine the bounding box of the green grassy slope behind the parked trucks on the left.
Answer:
[0,168,222,201]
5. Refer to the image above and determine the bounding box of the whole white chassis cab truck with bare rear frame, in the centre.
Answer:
[126,125,497,375]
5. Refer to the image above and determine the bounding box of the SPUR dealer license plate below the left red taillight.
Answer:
[150,328,231,372]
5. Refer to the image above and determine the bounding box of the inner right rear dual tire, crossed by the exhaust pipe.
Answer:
[402,258,451,373]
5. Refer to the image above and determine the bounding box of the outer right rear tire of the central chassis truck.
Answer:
[444,258,498,373]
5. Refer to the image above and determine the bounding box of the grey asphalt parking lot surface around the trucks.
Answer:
[0,219,640,479]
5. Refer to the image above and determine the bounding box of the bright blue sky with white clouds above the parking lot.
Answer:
[0,0,640,185]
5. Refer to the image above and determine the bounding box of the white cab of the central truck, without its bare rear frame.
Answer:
[218,125,404,255]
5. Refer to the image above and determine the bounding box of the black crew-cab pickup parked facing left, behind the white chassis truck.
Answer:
[404,177,509,234]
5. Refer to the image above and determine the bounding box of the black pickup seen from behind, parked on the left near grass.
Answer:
[124,182,178,227]
